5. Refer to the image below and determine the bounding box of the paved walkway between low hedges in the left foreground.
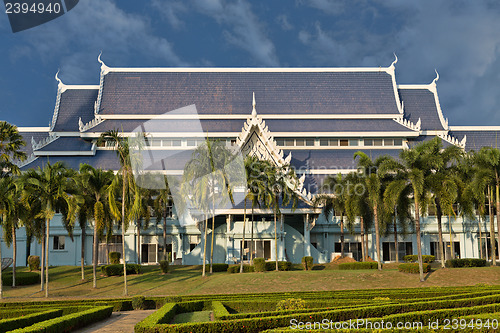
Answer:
[73,310,156,333]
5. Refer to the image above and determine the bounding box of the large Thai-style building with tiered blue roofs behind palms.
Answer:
[2,58,500,265]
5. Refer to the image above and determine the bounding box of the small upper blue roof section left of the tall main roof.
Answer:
[54,89,99,132]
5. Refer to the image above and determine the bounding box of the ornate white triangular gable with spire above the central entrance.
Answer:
[236,93,312,203]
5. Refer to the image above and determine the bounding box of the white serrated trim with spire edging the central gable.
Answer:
[236,93,312,204]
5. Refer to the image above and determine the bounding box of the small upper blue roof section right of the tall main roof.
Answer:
[399,89,444,130]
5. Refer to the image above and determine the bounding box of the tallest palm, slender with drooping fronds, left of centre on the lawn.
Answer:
[97,130,135,296]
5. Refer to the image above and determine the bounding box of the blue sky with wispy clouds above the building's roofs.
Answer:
[0,0,500,126]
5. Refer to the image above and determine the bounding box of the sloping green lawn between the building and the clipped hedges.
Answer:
[0,264,500,301]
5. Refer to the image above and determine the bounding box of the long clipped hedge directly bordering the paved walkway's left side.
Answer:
[12,306,113,333]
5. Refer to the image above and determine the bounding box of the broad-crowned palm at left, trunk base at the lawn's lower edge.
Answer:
[23,162,77,297]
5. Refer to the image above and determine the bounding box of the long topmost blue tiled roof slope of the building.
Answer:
[99,70,399,114]
